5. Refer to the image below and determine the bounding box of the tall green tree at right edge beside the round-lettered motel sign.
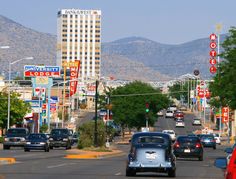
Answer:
[210,27,236,109]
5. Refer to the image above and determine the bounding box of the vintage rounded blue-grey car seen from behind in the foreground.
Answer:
[126,132,176,177]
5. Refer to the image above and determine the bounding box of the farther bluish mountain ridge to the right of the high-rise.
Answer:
[102,35,225,77]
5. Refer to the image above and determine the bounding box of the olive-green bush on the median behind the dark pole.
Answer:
[78,121,106,149]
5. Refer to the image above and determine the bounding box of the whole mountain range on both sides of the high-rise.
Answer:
[0,15,225,81]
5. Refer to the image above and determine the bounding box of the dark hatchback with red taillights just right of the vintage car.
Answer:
[174,136,203,161]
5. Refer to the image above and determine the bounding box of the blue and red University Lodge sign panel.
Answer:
[24,65,60,77]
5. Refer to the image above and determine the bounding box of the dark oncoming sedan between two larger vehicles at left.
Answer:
[24,133,49,152]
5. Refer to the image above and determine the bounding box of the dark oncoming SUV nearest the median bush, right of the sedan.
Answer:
[49,128,73,149]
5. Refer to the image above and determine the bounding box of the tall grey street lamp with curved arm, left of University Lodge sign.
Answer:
[7,57,34,129]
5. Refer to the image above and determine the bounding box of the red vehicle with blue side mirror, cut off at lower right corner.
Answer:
[215,149,236,179]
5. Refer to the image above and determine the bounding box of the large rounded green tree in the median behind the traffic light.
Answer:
[111,81,169,129]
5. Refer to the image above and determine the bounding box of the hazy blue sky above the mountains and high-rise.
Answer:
[0,0,236,44]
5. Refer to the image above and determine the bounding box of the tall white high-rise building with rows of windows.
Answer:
[57,9,101,80]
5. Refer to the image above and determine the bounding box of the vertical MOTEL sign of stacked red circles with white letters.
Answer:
[209,34,217,74]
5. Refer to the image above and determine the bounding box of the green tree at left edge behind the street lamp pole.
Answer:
[0,91,30,129]
